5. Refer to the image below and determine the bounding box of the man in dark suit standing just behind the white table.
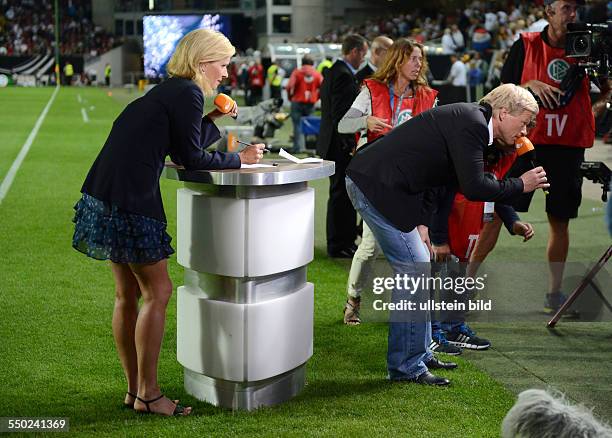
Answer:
[317,34,368,258]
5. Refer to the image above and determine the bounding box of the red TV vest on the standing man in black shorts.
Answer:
[521,32,595,148]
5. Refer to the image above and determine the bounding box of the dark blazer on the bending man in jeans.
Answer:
[346,103,523,232]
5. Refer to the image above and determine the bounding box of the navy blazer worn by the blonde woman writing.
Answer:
[81,78,240,222]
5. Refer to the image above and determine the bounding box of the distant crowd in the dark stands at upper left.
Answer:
[0,0,115,56]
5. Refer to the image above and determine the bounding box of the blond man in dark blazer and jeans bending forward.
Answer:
[346,84,549,386]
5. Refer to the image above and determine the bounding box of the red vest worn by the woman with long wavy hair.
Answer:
[363,79,438,142]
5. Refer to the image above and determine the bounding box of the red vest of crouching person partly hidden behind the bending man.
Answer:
[448,152,516,262]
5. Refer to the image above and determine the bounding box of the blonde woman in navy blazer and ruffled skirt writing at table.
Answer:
[72,29,264,415]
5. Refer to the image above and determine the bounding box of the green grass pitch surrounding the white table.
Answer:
[0,88,612,437]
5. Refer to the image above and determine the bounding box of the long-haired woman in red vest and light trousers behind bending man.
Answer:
[338,38,438,325]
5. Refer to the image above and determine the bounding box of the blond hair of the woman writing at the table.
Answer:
[166,29,236,95]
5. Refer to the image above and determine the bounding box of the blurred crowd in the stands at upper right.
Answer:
[305,0,607,94]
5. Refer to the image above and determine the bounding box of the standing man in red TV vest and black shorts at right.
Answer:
[471,0,606,313]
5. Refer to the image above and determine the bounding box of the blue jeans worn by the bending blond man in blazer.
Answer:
[346,177,433,380]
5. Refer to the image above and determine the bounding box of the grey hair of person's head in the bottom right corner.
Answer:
[501,389,612,438]
